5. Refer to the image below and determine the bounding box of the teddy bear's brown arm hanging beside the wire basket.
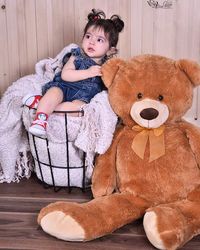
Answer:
[92,127,123,197]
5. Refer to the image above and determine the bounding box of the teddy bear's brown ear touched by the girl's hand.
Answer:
[102,58,125,88]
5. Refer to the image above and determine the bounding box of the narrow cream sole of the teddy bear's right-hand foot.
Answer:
[143,211,166,249]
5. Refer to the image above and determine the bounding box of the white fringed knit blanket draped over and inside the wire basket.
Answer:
[0,44,117,186]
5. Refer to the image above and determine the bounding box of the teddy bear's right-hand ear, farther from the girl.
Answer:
[176,59,200,86]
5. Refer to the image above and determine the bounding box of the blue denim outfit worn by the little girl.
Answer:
[42,48,105,103]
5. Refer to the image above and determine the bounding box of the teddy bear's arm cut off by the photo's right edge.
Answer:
[180,121,200,167]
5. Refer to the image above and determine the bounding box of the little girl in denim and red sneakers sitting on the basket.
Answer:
[23,9,124,137]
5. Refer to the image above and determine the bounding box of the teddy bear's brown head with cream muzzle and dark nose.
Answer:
[102,55,200,128]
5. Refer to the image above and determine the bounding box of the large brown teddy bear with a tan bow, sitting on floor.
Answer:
[38,55,200,249]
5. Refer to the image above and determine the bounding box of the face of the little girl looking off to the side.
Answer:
[82,26,110,63]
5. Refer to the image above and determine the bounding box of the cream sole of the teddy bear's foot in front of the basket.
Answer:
[40,211,85,241]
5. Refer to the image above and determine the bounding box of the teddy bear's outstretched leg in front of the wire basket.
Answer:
[38,194,150,241]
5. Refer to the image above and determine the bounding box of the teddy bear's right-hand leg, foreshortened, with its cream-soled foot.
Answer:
[143,187,200,249]
